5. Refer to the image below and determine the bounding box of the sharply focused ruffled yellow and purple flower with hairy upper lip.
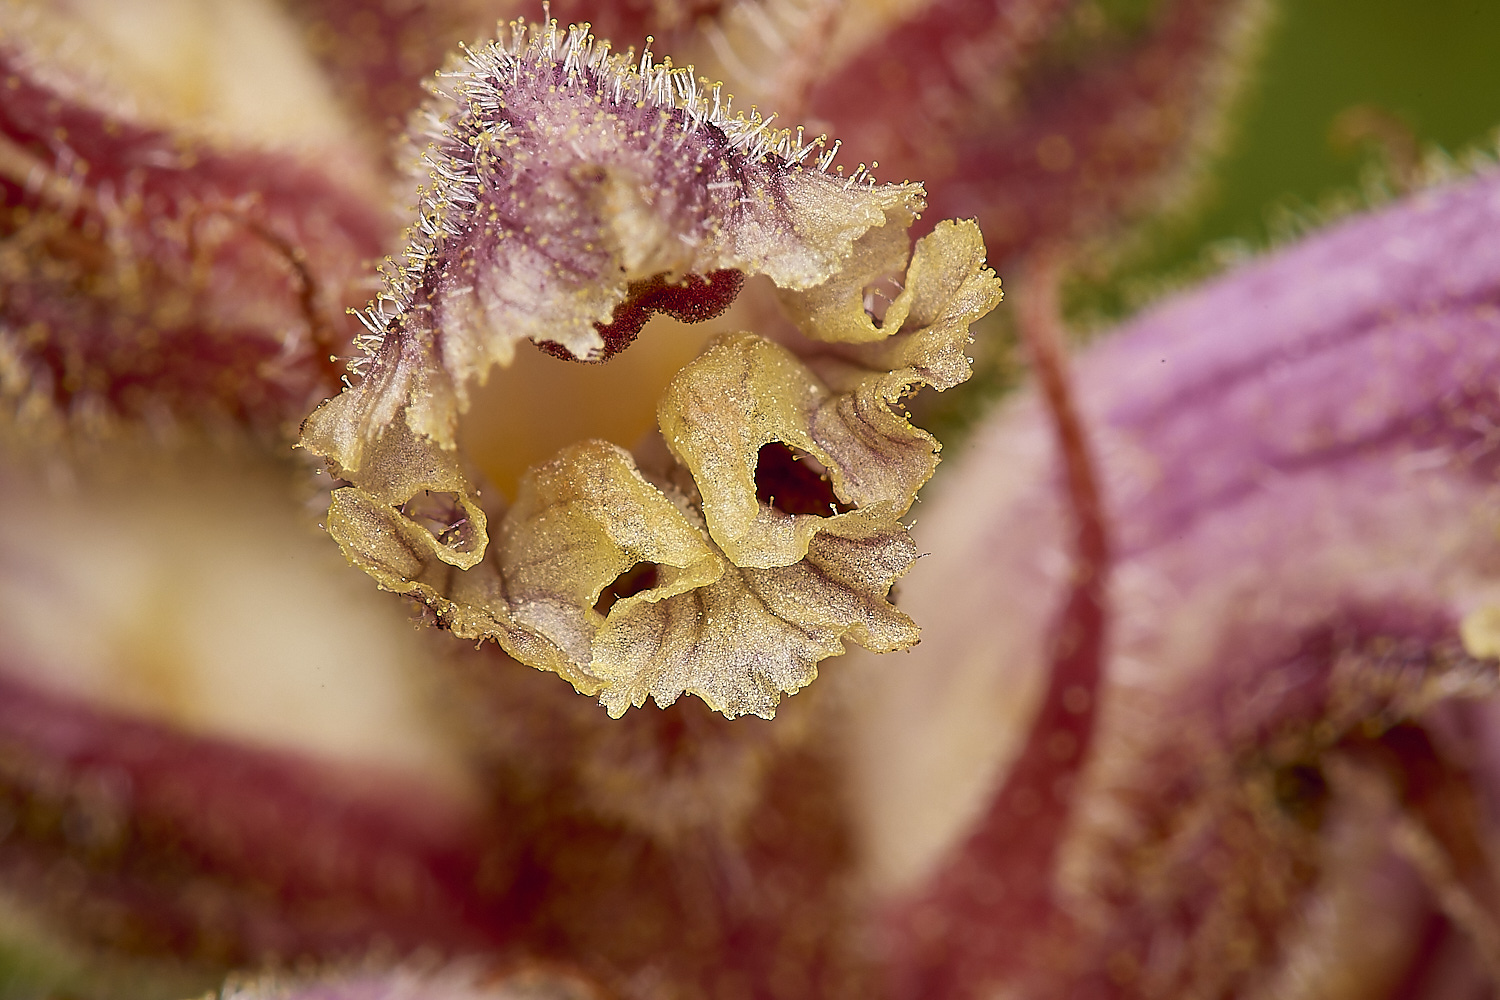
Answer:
[303,24,1001,717]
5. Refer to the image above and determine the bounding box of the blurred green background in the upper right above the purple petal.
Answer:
[1077,0,1500,319]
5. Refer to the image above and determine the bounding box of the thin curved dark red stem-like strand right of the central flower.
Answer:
[893,250,1110,999]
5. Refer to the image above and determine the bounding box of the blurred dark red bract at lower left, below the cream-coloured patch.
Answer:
[0,675,509,967]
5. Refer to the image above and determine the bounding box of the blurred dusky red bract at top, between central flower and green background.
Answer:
[809,0,1263,262]
